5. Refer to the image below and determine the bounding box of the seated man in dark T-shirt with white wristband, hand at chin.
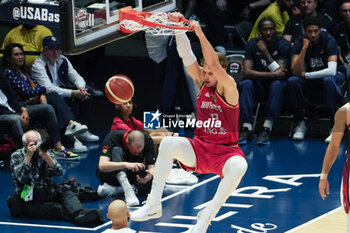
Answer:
[238,18,291,145]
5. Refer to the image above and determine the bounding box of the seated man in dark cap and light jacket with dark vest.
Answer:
[32,36,99,142]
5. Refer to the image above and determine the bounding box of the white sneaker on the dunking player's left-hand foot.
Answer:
[130,200,162,222]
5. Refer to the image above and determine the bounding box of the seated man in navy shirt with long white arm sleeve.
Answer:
[286,17,346,142]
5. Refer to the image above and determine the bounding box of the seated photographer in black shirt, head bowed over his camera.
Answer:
[97,130,156,206]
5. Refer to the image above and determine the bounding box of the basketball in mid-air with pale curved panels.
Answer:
[105,74,134,104]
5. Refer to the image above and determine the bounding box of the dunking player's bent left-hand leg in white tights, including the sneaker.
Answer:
[130,137,196,221]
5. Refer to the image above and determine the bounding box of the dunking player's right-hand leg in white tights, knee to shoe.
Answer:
[189,156,248,233]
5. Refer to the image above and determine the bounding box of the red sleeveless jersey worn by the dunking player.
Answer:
[195,85,239,145]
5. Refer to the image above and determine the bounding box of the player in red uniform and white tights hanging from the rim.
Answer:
[130,13,247,233]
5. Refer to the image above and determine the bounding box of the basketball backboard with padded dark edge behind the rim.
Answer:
[59,0,177,55]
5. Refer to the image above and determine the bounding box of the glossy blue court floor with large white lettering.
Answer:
[0,137,345,233]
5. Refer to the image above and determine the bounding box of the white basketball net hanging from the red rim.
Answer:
[120,13,190,36]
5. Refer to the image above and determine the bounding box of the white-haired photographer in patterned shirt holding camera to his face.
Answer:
[7,130,104,225]
